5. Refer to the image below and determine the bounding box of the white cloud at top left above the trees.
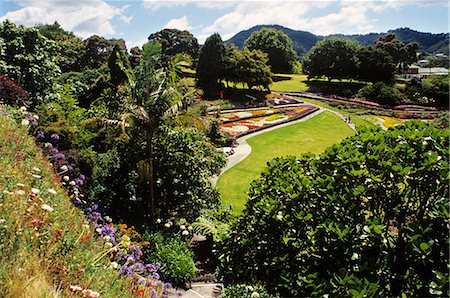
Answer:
[0,0,132,38]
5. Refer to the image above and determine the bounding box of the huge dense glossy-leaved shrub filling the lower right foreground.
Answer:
[220,122,449,297]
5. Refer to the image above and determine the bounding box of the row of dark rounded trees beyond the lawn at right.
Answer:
[302,34,418,83]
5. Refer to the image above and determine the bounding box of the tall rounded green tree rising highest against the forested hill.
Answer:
[245,28,296,73]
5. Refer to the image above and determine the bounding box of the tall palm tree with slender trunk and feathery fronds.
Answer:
[95,42,192,224]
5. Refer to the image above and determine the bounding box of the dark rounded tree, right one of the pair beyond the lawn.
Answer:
[356,47,395,83]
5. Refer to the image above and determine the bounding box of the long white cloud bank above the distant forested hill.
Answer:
[199,0,418,38]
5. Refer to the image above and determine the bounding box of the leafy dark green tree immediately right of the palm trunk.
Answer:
[153,125,225,222]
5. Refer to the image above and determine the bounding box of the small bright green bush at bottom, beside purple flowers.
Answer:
[144,232,195,287]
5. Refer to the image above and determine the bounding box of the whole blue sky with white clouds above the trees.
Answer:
[0,0,450,48]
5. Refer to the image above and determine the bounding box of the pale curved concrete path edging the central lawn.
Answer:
[210,103,356,186]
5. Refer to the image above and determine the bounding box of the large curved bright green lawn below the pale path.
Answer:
[217,112,354,214]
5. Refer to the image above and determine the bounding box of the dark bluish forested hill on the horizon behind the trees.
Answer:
[226,25,449,56]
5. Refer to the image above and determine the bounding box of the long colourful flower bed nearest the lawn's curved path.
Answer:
[220,105,318,138]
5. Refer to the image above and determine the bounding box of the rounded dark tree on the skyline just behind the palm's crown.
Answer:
[148,29,199,64]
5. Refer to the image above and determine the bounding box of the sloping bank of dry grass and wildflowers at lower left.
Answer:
[0,110,132,297]
